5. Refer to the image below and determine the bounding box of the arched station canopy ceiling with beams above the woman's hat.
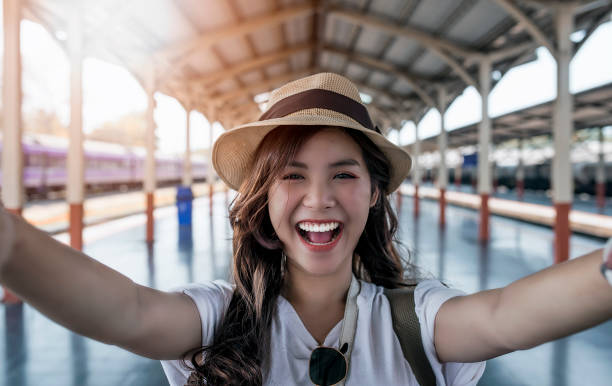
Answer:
[23,0,612,138]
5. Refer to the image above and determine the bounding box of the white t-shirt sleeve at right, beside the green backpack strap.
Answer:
[414,280,485,386]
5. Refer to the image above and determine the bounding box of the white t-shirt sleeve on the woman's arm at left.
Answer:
[161,280,234,386]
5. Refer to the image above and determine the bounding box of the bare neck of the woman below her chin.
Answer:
[283,264,352,309]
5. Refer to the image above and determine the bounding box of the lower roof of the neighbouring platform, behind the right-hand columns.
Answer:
[421,83,612,152]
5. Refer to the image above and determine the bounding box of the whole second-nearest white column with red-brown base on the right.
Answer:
[478,59,491,241]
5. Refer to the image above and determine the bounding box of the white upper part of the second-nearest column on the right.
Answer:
[478,59,491,194]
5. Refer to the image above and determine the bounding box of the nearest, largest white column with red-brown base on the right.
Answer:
[552,3,574,263]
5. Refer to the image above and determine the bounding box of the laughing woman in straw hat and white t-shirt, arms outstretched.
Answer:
[0,74,612,385]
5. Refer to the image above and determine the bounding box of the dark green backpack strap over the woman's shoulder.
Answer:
[384,286,436,386]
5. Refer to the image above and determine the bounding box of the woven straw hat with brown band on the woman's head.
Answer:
[212,73,412,193]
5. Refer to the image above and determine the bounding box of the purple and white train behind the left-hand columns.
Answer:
[0,133,208,200]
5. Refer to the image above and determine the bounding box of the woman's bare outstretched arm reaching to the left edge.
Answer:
[0,210,202,359]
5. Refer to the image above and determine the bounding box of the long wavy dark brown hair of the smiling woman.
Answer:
[186,126,416,385]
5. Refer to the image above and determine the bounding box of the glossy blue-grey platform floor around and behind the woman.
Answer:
[0,192,612,386]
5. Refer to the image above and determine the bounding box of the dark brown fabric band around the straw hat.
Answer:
[259,89,380,133]
